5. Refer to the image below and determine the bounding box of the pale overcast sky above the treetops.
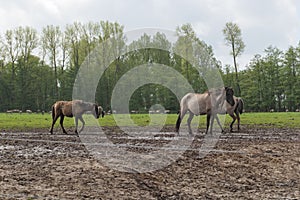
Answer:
[0,0,300,69]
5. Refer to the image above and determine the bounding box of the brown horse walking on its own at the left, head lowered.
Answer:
[50,100,104,134]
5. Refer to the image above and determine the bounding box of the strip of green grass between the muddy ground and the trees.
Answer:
[0,112,300,131]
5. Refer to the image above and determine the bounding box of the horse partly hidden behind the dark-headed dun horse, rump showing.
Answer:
[218,96,244,132]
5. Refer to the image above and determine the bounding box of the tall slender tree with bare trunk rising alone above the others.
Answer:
[223,22,245,96]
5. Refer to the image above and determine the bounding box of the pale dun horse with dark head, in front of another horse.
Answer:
[176,87,234,134]
